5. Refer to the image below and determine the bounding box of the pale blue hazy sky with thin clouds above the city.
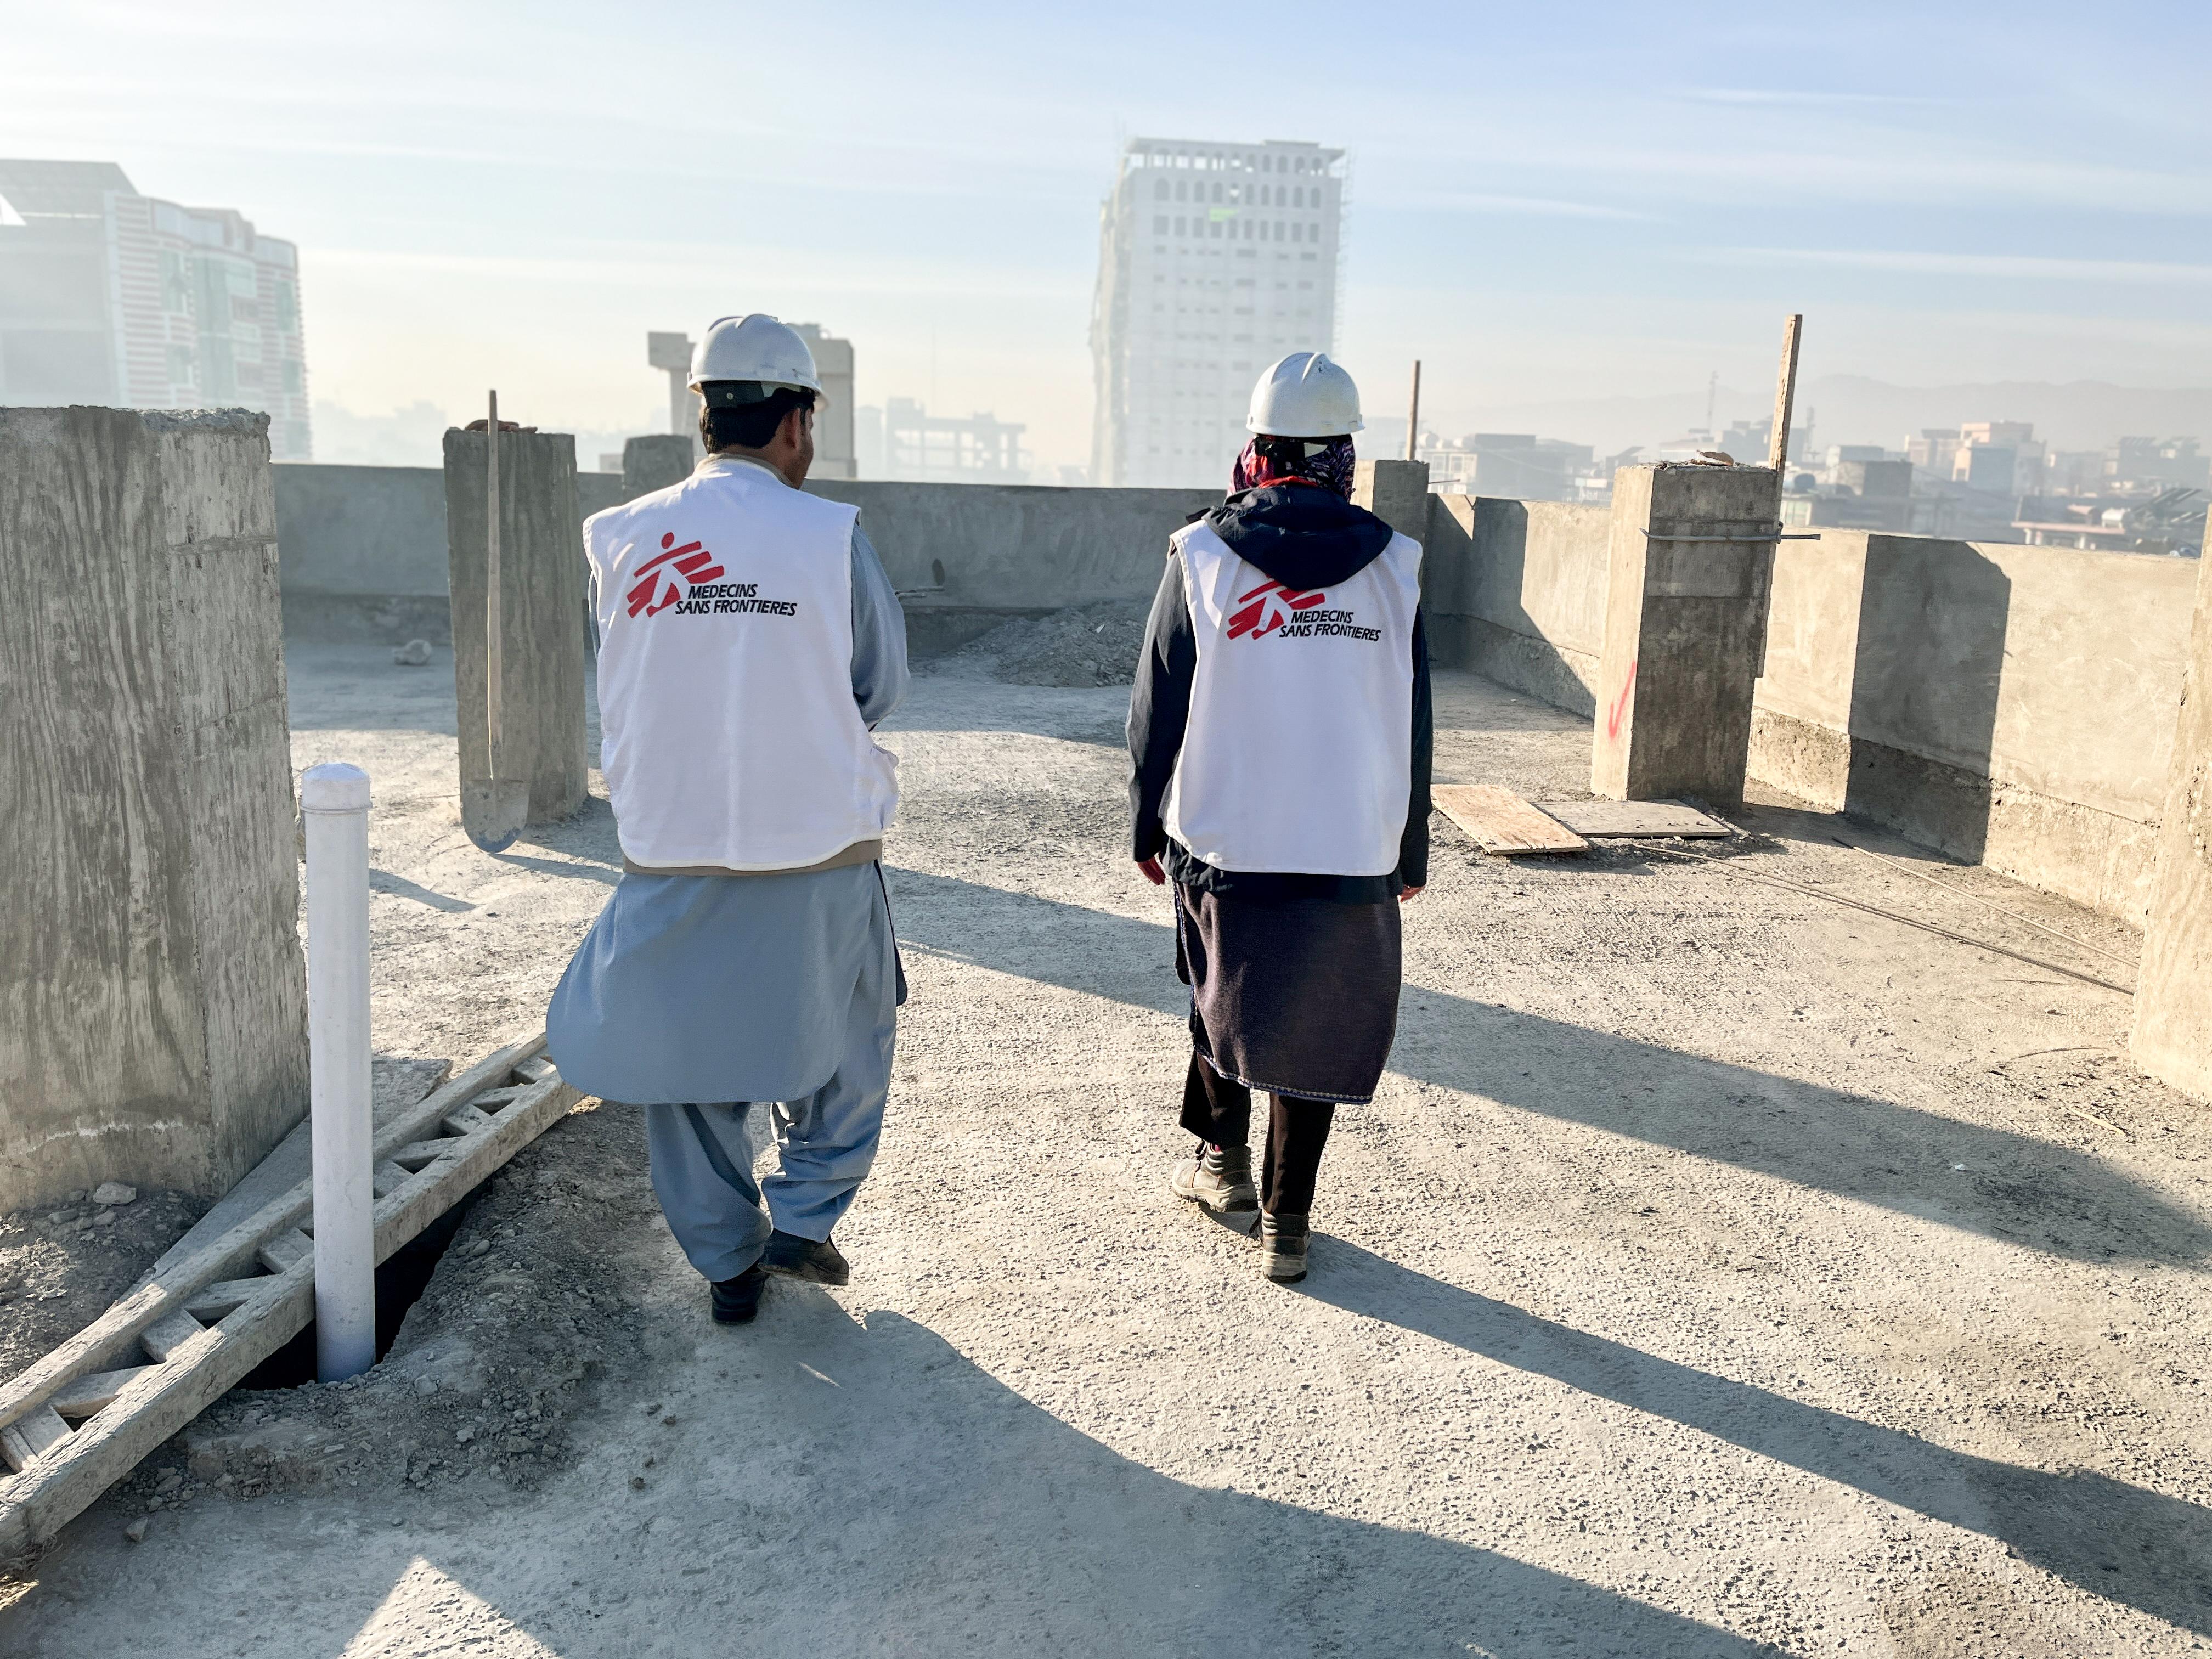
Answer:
[0,0,2212,462]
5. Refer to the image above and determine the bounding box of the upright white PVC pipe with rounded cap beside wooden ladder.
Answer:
[298,763,376,1383]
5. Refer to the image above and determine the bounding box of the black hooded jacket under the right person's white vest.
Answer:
[1128,484,1434,905]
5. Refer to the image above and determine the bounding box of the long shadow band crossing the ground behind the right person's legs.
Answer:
[889,870,2212,1263]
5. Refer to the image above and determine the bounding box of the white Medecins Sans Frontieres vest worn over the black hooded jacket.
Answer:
[1166,520,1420,876]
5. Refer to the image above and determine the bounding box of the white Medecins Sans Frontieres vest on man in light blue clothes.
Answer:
[584,458,898,870]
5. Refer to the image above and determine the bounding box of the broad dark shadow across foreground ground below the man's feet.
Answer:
[0,1288,1783,1659]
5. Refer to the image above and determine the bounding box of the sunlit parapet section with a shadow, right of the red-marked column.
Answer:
[1752,531,2199,924]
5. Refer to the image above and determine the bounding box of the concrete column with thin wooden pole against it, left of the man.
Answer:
[444,429,584,823]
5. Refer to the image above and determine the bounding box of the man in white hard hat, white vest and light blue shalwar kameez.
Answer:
[546,314,907,1325]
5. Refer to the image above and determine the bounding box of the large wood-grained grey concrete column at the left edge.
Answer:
[0,409,307,1210]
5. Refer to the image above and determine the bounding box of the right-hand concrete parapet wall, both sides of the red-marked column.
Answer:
[1427,495,2201,924]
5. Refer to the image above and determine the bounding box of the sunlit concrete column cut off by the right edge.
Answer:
[2130,560,2212,1099]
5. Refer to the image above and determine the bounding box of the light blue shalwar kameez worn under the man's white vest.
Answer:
[546,513,907,1281]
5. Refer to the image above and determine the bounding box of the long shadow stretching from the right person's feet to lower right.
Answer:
[1305,1239,2212,1633]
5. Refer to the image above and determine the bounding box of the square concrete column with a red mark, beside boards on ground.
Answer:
[1590,462,1781,805]
